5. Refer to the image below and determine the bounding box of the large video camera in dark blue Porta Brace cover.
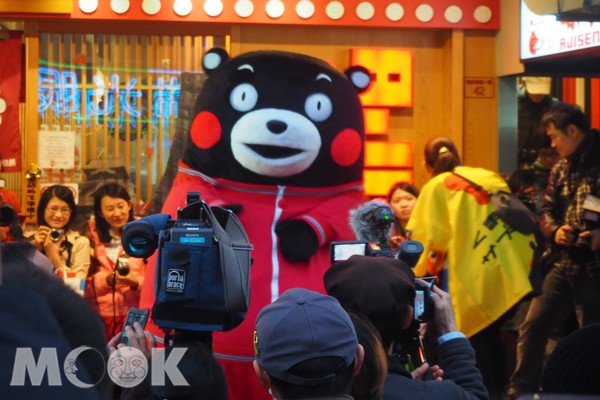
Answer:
[122,192,253,332]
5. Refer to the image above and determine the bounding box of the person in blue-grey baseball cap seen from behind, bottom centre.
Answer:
[254,288,364,400]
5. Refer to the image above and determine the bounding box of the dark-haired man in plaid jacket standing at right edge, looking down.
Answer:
[510,104,600,397]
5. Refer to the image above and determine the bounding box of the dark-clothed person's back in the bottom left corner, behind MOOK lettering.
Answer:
[0,241,112,400]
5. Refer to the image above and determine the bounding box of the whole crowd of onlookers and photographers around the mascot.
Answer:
[0,100,600,400]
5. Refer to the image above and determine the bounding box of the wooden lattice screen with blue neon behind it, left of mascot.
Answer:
[38,33,229,214]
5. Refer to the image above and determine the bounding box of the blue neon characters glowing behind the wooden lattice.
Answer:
[38,63,181,134]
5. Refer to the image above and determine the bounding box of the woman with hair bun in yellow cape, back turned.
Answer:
[407,137,535,396]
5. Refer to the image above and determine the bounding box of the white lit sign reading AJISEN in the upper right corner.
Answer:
[521,1,600,60]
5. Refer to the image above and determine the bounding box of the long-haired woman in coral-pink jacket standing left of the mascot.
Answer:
[86,183,145,340]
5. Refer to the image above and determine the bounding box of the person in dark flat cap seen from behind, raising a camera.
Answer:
[324,255,488,400]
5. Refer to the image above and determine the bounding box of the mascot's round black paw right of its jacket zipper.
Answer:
[275,219,319,263]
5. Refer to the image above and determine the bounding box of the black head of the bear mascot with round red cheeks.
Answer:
[183,48,371,187]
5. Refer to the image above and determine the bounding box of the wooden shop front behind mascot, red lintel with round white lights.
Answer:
[0,0,500,219]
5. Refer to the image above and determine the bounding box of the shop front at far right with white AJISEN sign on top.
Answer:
[499,0,600,173]
